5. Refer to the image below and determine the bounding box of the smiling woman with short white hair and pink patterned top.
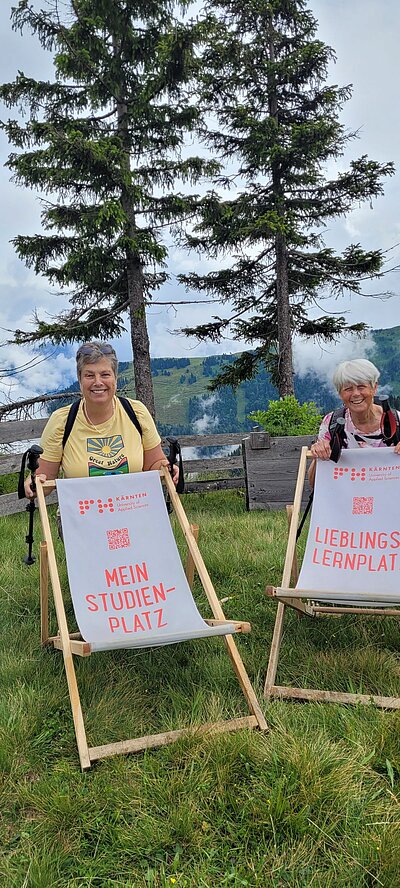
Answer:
[308,358,400,485]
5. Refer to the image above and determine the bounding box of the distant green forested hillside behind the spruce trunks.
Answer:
[50,327,400,435]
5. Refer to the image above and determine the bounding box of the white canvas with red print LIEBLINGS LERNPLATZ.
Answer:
[296,447,400,607]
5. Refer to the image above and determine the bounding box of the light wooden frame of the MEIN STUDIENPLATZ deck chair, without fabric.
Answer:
[37,469,267,770]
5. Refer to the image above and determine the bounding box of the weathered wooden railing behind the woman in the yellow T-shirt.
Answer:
[0,419,245,515]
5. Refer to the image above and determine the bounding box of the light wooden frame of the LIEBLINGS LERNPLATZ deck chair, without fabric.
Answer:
[264,447,400,709]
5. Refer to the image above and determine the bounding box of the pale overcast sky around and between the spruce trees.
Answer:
[0,0,400,402]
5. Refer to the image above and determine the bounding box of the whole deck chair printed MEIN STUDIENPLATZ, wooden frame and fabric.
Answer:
[37,469,267,770]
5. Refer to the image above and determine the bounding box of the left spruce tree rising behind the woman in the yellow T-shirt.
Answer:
[0,0,215,415]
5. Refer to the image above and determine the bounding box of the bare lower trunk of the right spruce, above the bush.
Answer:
[275,232,294,398]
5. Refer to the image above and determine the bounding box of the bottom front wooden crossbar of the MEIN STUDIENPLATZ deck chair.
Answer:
[89,715,257,762]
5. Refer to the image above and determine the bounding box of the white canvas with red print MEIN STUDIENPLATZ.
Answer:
[56,472,235,651]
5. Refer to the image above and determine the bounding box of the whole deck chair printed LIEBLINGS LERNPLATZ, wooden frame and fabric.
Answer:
[264,447,400,709]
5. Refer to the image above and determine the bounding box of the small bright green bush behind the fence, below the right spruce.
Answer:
[249,395,322,435]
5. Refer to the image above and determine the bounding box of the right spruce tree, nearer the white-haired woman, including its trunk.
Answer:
[181,0,394,396]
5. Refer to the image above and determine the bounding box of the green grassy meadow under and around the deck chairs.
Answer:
[0,491,400,888]
